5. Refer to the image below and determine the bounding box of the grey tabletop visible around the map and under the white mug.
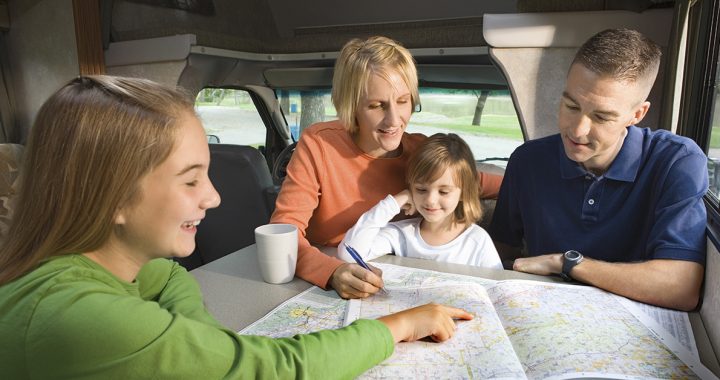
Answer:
[190,244,720,375]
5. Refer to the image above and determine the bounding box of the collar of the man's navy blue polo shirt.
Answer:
[558,125,643,182]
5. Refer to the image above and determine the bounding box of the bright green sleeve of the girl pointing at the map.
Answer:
[27,278,394,379]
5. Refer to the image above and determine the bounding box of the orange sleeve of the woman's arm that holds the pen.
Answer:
[270,134,343,289]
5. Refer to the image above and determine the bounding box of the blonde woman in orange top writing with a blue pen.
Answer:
[271,37,502,298]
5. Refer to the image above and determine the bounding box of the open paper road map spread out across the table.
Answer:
[241,264,715,379]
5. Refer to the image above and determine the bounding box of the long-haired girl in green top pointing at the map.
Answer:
[0,76,472,379]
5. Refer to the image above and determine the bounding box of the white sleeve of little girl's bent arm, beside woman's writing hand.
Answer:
[338,195,400,263]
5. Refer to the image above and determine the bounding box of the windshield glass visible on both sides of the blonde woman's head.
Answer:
[276,88,523,167]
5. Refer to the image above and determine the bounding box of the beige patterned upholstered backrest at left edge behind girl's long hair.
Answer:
[0,144,24,243]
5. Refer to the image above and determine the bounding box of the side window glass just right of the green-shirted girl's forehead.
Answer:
[195,88,267,148]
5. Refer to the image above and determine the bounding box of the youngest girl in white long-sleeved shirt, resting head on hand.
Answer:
[338,133,503,269]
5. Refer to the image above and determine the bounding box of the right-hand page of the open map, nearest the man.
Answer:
[487,280,715,379]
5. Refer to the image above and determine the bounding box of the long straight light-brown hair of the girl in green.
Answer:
[0,76,194,284]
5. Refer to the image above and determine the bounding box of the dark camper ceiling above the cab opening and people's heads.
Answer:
[109,0,672,54]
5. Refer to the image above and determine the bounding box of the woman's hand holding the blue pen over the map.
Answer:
[329,263,385,299]
